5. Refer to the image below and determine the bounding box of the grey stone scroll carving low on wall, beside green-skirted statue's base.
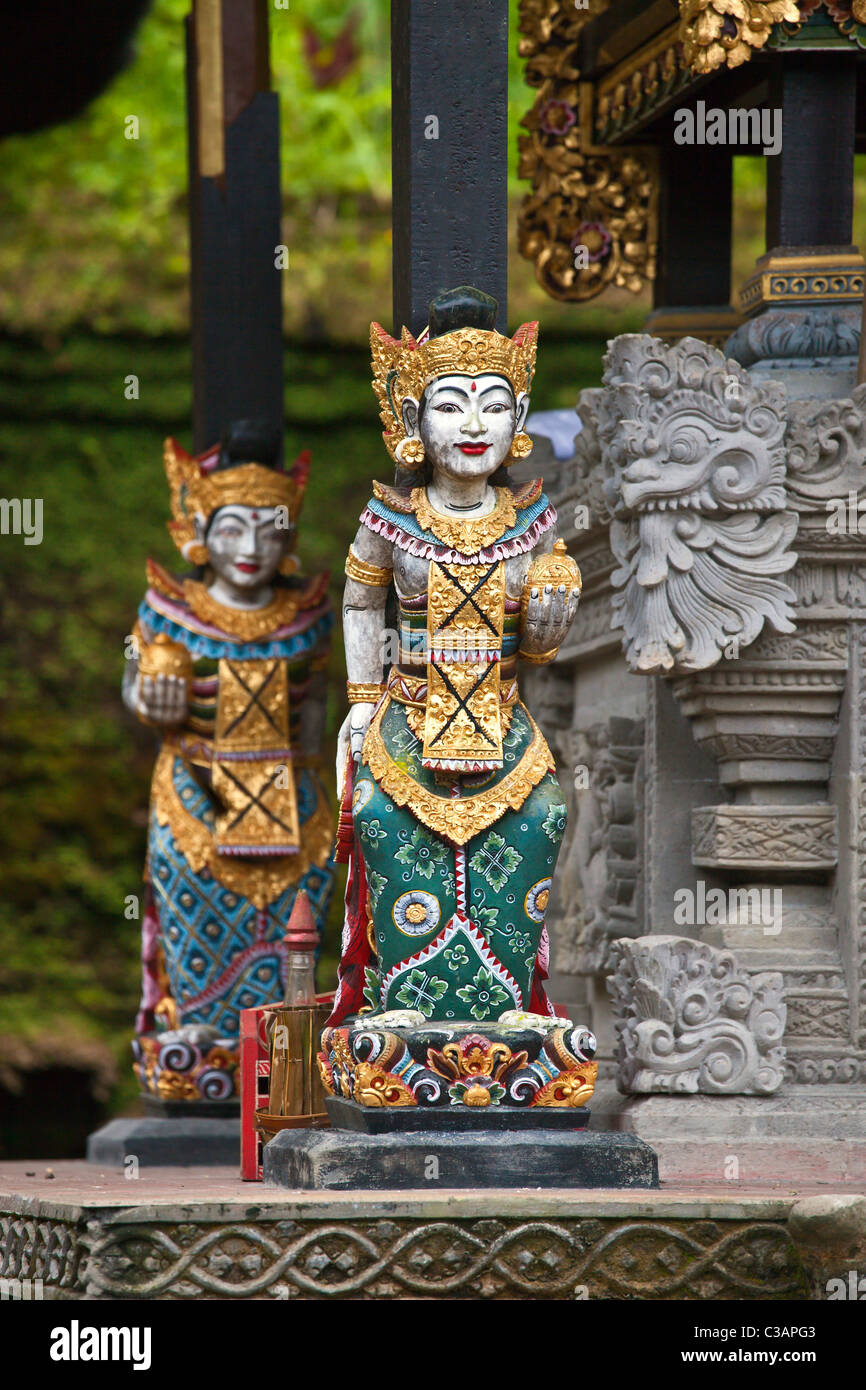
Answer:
[607,935,785,1095]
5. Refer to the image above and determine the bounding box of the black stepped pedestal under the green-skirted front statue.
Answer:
[263,1101,659,1191]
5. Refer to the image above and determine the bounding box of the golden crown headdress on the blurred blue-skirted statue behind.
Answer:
[163,439,310,563]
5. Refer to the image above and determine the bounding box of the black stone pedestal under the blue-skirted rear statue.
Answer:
[88,1113,240,1169]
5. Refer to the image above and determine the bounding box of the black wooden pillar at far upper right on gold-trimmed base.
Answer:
[766,51,856,250]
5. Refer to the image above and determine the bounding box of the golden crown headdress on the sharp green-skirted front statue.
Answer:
[370,304,538,459]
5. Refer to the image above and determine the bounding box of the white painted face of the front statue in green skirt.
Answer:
[403,373,530,478]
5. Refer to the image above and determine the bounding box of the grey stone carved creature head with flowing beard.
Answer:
[594,334,796,674]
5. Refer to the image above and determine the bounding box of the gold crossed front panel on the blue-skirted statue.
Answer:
[213,657,300,856]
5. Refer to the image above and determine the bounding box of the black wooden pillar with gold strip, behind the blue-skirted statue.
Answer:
[186,0,282,452]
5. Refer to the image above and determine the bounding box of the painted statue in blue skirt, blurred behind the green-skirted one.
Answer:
[124,421,334,1101]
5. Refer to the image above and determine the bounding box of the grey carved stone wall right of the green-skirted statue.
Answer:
[549,335,866,1128]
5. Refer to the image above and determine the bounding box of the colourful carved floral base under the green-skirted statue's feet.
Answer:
[318,1011,598,1109]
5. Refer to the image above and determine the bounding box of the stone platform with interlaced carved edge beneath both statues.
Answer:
[0,1162,866,1301]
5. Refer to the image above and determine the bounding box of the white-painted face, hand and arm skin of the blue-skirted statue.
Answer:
[124,503,332,748]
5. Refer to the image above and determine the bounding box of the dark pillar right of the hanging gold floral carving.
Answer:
[653,140,733,309]
